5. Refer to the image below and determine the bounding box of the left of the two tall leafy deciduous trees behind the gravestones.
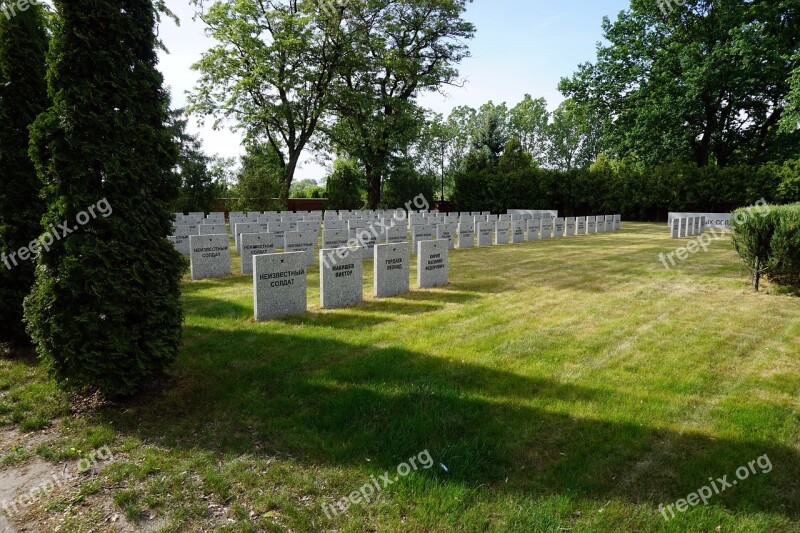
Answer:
[190,0,348,204]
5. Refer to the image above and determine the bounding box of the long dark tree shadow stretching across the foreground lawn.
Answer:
[99,327,800,518]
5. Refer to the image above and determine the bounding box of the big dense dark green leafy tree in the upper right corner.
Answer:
[560,0,800,166]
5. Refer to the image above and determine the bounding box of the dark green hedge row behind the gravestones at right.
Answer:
[453,157,800,222]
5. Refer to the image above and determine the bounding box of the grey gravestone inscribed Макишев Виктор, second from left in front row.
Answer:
[319,248,364,309]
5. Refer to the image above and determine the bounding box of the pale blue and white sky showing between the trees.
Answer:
[159,0,630,181]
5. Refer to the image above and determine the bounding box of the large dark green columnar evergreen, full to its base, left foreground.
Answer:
[25,0,185,398]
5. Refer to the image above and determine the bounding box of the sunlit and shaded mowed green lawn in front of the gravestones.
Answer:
[0,224,800,532]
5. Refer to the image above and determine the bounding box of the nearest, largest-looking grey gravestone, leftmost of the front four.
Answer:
[253,252,308,322]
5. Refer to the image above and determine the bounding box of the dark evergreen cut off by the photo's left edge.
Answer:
[0,2,48,345]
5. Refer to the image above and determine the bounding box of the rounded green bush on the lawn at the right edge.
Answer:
[731,204,800,291]
